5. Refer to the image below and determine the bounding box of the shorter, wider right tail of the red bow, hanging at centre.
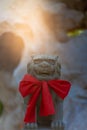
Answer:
[40,81,55,116]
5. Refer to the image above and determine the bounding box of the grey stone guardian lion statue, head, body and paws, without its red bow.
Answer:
[25,55,63,128]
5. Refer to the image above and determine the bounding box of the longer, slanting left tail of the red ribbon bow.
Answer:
[24,88,40,123]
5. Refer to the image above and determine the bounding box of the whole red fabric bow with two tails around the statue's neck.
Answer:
[19,74,71,123]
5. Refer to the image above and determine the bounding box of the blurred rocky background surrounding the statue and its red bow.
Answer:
[0,0,87,130]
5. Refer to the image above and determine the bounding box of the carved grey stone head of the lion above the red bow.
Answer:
[27,55,61,80]
